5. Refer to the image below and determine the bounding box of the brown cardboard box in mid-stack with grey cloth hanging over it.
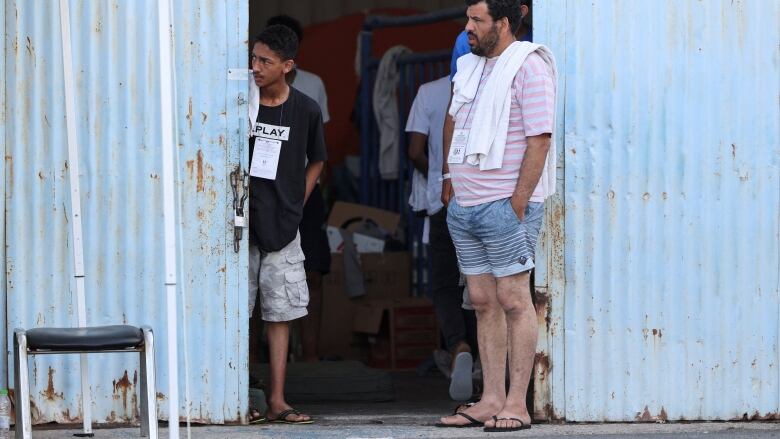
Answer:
[319,252,411,361]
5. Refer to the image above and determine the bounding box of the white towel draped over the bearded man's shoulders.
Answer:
[449,41,557,196]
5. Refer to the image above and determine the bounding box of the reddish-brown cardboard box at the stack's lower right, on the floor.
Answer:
[353,298,439,370]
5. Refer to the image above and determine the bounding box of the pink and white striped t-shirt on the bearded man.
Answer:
[449,53,555,206]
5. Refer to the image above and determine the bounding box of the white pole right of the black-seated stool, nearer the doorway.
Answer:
[158,0,179,439]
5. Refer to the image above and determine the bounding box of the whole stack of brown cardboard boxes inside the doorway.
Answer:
[320,203,438,369]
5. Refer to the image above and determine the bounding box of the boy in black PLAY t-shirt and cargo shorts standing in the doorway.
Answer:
[249,26,326,424]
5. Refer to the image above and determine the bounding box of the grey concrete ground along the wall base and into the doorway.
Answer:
[18,373,780,439]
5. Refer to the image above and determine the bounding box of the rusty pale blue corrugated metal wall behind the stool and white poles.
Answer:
[2,0,248,423]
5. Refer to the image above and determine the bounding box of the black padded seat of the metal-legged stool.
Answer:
[27,325,144,352]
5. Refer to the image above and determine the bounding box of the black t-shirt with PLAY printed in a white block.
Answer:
[249,87,327,252]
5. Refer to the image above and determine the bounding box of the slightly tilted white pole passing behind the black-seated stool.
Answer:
[60,0,92,434]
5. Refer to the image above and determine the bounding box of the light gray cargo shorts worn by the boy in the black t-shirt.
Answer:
[249,234,309,322]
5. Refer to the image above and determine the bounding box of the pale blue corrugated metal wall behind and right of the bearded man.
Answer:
[535,0,780,421]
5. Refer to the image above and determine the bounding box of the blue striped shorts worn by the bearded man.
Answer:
[447,198,544,277]
